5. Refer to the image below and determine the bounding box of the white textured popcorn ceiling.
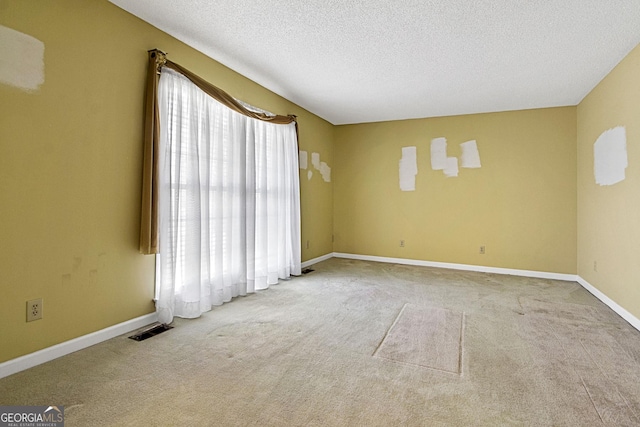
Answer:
[110,0,640,124]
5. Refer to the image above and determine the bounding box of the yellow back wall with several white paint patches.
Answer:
[334,107,576,274]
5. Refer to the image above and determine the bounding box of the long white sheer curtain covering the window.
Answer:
[156,68,300,323]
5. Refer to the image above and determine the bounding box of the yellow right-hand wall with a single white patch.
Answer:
[577,46,640,318]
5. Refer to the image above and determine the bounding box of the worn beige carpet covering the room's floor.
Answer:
[0,259,640,426]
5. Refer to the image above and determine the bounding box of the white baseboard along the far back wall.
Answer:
[333,252,578,282]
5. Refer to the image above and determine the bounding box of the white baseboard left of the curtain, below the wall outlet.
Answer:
[0,313,158,378]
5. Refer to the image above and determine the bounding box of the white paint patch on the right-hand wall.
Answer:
[593,126,629,185]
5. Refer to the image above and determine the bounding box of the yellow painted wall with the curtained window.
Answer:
[0,0,334,362]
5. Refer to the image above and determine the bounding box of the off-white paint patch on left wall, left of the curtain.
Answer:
[0,25,44,92]
